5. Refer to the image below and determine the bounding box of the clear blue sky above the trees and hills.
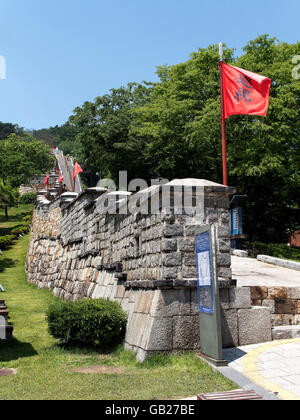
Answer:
[0,0,300,129]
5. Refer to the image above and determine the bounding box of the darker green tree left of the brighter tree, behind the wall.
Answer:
[70,83,151,185]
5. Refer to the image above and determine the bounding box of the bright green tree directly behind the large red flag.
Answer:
[132,35,300,241]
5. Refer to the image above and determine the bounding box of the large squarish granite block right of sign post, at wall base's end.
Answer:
[238,306,272,346]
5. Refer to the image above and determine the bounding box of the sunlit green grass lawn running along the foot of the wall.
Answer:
[0,208,237,400]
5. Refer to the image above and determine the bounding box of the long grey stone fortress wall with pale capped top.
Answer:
[26,179,272,361]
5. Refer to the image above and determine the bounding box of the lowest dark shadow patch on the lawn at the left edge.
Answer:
[0,338,38,363]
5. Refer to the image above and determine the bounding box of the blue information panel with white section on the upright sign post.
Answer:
[195,231,214,314]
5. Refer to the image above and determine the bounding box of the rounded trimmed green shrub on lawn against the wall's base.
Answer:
[46,298,127,349]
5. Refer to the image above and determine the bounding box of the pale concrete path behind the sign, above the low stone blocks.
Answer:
[231,256,300,287]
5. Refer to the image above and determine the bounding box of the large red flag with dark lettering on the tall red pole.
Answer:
[221,63,272,119]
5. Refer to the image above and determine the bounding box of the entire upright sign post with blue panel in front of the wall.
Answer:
[195,225,227,366]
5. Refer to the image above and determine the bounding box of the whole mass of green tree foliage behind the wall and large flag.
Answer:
[70,35,300,241]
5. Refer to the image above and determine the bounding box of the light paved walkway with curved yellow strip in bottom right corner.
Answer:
[222,339,300,400]
